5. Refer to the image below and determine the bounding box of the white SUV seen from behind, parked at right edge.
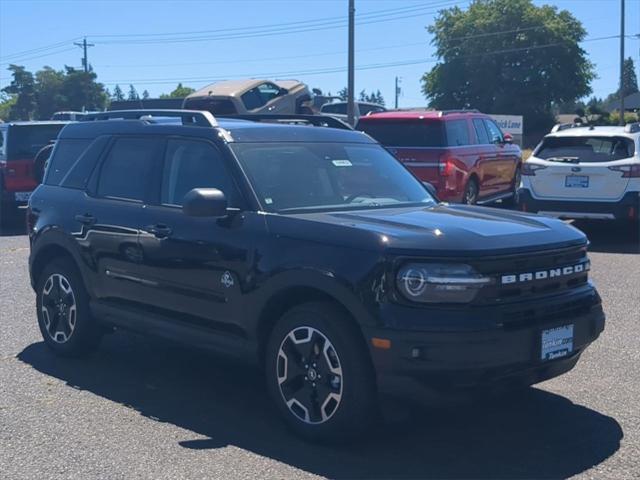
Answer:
[518,123,640,221]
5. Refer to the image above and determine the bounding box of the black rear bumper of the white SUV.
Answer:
[518,188,640,220]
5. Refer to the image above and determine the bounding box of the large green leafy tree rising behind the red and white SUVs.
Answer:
[422,0,595,132]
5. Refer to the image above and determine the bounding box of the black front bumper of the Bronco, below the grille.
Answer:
[365,285,605,393]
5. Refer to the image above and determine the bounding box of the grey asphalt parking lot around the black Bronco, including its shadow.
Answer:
[0,218,640,479]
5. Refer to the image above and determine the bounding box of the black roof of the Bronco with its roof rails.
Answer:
[59,117,376,143]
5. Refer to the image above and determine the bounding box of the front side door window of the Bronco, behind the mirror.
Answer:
[160,140,237,205]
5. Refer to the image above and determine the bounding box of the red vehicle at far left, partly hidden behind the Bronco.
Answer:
[0,121,68,220]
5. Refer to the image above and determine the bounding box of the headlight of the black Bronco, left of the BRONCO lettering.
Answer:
[396,263,491,303]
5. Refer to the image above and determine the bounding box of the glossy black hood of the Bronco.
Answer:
[270,204,587,257]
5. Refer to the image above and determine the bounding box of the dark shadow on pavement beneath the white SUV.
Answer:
[573,220,640,253]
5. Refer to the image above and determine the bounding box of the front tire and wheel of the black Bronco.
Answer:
[265,302,377,442]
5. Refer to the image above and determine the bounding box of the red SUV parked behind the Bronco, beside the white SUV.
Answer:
[356,110,522,204]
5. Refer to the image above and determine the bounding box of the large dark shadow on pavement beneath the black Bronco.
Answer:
[18,333,623,478]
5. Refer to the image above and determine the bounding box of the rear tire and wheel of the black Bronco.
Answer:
[36,259,102,357]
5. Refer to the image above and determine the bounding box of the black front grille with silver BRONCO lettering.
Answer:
[472,247,589,304]
